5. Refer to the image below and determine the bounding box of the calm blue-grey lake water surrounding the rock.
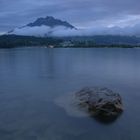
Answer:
[0,48,140,140]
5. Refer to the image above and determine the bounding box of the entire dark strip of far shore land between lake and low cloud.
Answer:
[0,35,140,48]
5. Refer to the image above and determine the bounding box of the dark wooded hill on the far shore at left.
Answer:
[0,35,62,48]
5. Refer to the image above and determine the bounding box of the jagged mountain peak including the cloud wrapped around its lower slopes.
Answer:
[7,16,77,37]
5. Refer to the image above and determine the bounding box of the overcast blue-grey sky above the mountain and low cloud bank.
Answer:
[0,0,140,32]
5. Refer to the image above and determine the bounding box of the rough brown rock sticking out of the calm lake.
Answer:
[76,88,123,119]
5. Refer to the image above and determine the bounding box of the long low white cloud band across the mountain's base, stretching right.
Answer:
[7,24,140,37]
